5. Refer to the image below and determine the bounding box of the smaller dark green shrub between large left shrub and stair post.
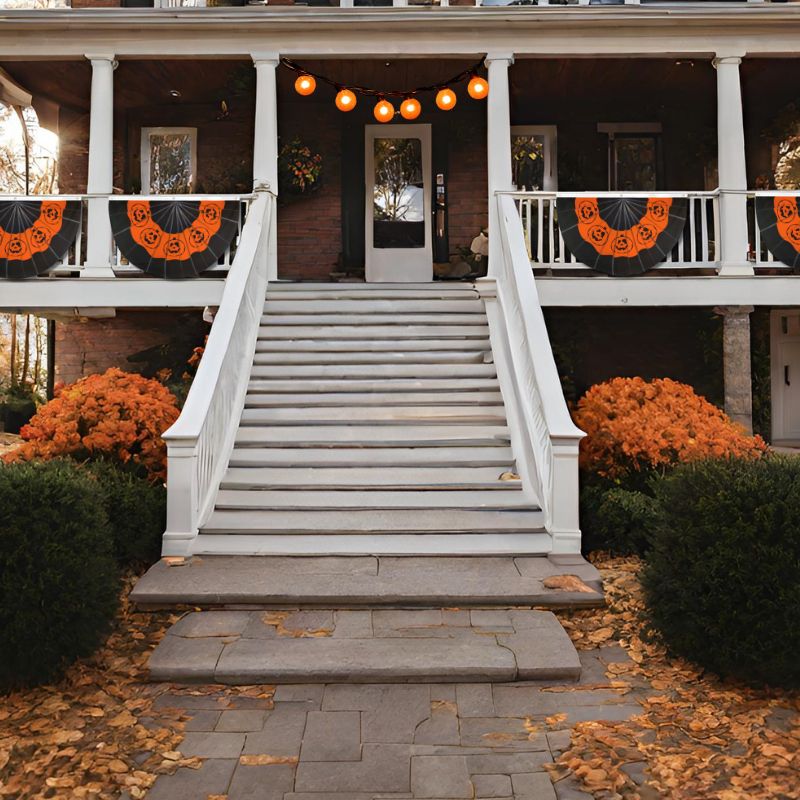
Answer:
[84,461,167,567]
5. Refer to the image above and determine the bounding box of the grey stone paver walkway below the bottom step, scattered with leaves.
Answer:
[138,647,641,800]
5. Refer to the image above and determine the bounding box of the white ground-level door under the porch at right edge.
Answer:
[771,310,800,442]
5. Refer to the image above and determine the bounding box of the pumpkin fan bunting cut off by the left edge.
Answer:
[0,199,81,280]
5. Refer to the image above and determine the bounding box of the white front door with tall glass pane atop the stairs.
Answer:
[365,124,433,283]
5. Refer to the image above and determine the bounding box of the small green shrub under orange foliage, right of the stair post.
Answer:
[580,483,658,555]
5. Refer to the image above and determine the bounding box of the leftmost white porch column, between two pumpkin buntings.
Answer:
[82,53,116,278]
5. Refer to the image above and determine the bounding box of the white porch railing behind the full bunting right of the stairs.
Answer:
[511,191,720,270]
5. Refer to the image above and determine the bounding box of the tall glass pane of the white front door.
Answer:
[372,138,425,248]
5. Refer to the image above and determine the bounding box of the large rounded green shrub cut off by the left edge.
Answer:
[0,461,119,690]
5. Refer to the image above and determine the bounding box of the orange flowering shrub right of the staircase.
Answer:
[574,378,767,480]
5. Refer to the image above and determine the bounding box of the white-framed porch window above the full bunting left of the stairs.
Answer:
[142,128,197,194]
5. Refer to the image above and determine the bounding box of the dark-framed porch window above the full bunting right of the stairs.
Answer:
[597,122,663,192]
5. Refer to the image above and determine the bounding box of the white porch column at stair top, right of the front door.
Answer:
[486,53,514,276]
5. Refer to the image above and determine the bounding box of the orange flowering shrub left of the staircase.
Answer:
[5,368,179,481]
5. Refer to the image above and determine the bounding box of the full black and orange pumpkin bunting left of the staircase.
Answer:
[108,199,239,278]
